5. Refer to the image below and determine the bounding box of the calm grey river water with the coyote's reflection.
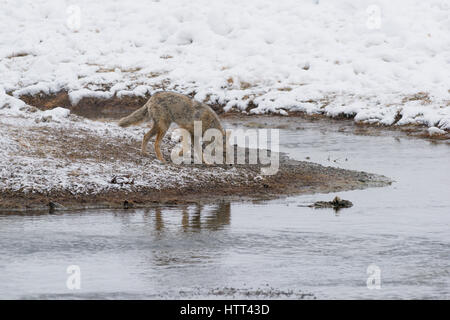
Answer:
[0,120,450,299]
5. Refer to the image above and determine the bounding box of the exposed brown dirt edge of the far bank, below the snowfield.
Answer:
[14,90,450,143]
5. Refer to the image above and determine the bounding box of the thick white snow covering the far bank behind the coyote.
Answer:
[0,0,450,132]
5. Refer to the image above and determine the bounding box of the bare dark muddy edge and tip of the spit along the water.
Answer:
[0,154,392,212]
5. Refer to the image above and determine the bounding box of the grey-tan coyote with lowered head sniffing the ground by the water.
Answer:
[119,92,226,162]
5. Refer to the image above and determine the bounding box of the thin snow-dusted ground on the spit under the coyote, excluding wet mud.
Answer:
[0,104,250,194]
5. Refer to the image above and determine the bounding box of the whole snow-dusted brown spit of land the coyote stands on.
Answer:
[0,104,390,210]
